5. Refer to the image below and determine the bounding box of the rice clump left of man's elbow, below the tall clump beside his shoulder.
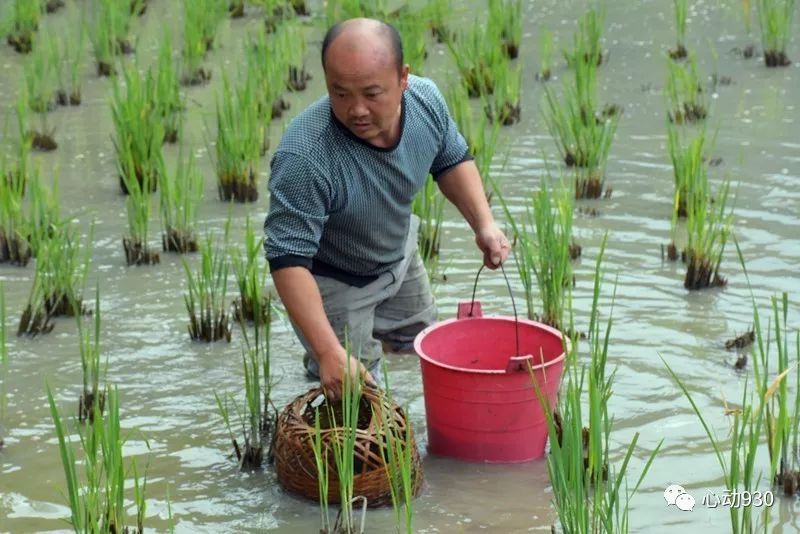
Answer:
[158,145,203,253]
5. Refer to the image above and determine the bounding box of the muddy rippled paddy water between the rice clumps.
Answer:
[0,0,800,532]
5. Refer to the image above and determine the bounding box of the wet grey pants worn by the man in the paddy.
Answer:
[292,217,436,383]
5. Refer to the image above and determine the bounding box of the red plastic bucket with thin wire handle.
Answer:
[414,300,569,463]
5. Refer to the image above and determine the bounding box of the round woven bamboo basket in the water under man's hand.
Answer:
[272,387,422,508]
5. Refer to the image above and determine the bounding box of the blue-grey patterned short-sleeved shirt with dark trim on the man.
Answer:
[264,75,471,285]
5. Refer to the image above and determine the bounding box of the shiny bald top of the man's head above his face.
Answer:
[322,18,403,74]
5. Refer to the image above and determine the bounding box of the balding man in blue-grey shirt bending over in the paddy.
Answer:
[264,19,509,399]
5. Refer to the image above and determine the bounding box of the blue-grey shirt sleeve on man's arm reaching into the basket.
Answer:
[264,152,333,271]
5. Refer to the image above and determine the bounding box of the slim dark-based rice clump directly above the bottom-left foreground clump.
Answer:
[76,286,108,423]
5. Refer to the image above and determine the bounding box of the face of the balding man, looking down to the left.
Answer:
[325,43,408,147]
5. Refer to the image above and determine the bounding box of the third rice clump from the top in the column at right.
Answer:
[667,122,708,222]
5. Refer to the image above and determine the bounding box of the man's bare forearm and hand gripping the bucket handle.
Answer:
[437,160,510,269]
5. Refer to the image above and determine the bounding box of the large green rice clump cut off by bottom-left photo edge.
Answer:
[47,386,147,534]
